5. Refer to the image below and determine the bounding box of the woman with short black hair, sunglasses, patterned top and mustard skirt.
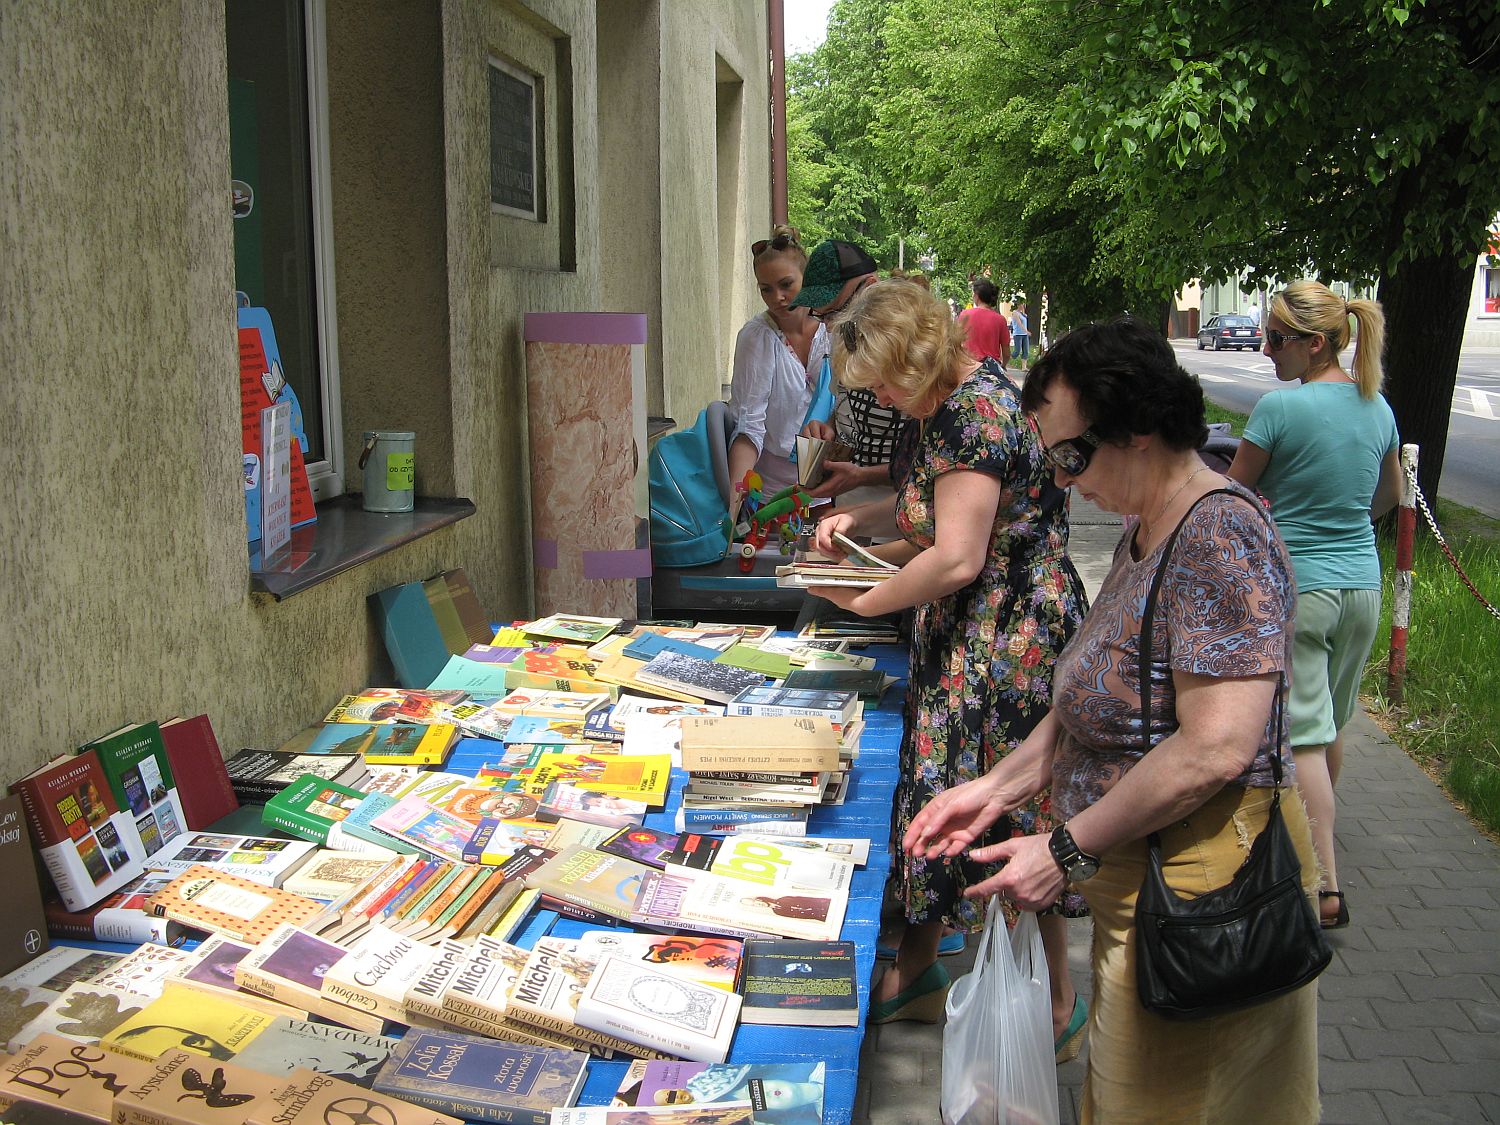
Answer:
[903,321,1319,1122]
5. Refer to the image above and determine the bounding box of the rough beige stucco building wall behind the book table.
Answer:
[0,0,770,782]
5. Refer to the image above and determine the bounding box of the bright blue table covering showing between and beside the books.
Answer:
[446,645,906,1125]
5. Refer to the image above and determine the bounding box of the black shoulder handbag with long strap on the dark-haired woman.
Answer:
[1136,489,1334,1020]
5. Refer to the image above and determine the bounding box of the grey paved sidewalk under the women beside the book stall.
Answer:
[854,498,1500,1125]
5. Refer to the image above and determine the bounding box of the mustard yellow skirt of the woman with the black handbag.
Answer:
[1082,788,1319,1125]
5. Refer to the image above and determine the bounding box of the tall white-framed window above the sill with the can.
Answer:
[225,0,344,500]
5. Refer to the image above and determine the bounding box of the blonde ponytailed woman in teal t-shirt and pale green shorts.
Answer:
[1229,281,1401,929]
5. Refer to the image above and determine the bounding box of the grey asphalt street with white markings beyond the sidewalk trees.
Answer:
[1172,341,1500,519]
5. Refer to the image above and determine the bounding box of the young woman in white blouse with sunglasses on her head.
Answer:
[729,227,828,497]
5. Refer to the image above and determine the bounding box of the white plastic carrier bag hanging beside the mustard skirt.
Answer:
[942,899,1058,1125]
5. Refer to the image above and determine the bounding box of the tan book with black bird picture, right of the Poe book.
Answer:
[114,1056,288,1125]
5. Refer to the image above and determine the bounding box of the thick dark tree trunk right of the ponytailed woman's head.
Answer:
[1380,257,1475,503]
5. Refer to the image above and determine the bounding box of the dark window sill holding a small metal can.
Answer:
[251,497,474,602]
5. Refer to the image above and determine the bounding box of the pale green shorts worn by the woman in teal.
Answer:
[1290,590,1380,747]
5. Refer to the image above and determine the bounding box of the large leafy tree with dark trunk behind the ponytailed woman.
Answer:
[1068,0,1500,497]
